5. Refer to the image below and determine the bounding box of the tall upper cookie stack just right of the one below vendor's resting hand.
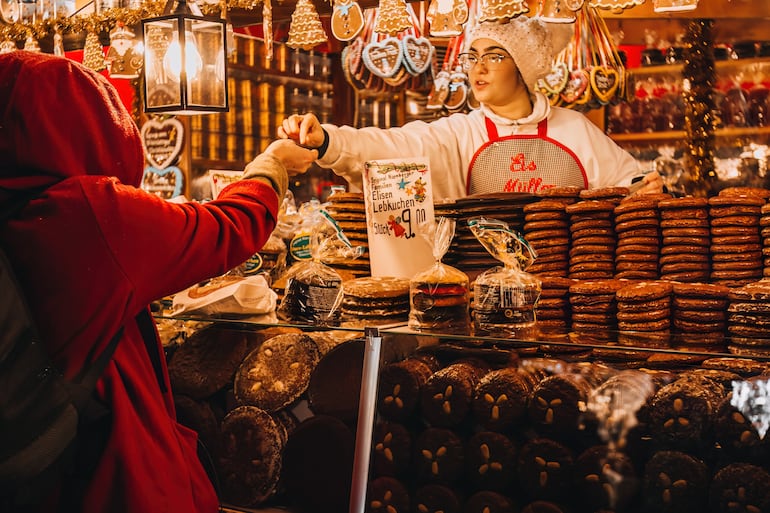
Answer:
[658,197,711,283]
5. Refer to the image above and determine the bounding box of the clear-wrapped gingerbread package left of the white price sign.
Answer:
[278,209,365,326]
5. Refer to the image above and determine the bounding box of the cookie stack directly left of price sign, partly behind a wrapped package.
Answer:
[325,192,370,277]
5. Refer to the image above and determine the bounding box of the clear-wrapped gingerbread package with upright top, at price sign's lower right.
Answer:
[409,217,470,335]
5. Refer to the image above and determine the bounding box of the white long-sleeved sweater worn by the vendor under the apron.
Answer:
[318,93,640,200]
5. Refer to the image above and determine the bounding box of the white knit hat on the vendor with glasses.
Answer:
[467,16,575,92]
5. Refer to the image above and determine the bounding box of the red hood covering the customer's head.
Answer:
[0,51,144,189]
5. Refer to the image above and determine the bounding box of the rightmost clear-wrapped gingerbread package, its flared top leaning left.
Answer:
[468,217,541,340]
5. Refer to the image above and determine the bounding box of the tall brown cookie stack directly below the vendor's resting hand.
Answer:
[614,196,660,280]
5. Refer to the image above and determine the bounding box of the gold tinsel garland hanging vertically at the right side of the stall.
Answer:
[682,20,717,196]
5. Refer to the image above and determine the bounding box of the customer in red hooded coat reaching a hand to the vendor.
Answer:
[0,51,317,513]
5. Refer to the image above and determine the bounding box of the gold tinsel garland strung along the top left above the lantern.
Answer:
[0,0,262,41]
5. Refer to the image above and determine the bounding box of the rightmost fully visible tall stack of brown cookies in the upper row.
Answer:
[708,194,765,287]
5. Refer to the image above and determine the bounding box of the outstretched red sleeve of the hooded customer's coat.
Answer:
[84,176,278,308]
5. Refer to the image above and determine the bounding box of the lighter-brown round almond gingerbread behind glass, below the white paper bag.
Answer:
[233,333,320,412]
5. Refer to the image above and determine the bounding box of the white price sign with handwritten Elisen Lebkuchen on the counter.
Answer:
[364,158,435,278]
